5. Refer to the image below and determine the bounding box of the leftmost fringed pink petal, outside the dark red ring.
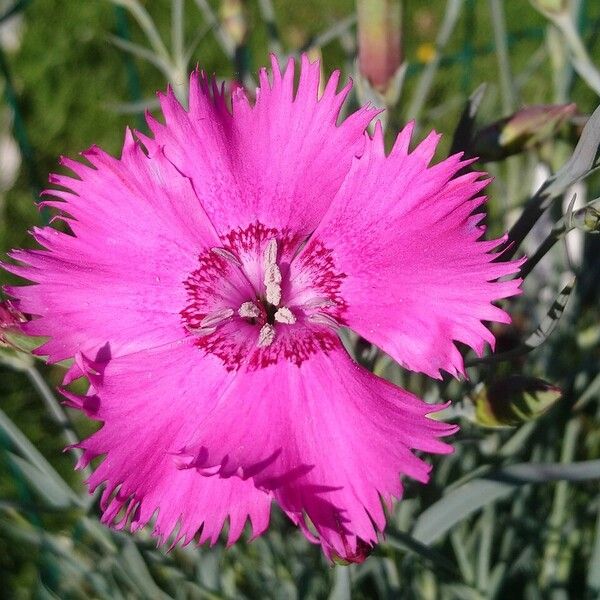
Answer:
[4,133,219,361]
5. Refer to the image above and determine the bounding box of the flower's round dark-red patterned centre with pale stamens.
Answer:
[181,223,345,369]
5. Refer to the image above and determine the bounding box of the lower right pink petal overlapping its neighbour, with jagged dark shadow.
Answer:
[175,345,456,556]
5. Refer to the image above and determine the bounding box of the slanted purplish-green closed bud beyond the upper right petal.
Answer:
[471,104,577,161]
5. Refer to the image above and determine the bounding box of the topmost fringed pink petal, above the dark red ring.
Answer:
[147,56,377,237]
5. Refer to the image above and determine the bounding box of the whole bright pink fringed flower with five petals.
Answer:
[5,57,519,561]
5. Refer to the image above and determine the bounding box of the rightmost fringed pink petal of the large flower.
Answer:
[292,125,520,377]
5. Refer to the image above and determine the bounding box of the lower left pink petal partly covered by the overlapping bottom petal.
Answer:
[66,342,271,544]
